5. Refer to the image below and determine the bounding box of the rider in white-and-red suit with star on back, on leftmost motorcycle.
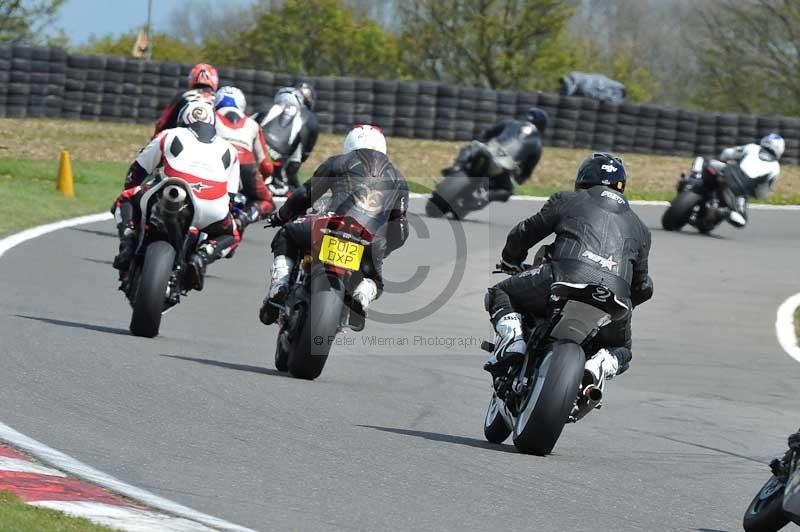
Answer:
[113,101,240,290]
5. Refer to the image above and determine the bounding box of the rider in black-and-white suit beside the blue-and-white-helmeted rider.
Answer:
[253,82,319,193]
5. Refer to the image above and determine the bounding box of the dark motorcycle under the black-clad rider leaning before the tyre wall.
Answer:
[425,140,519,220]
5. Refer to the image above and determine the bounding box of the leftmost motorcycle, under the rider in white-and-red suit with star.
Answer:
[120,178,212,338]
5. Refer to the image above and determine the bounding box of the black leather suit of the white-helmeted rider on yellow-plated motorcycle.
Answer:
[272,150,408,291]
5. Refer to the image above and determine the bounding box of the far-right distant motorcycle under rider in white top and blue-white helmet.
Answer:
[661,161,732,234]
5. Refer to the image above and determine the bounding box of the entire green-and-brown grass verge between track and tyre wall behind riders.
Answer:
[0,118,800,235]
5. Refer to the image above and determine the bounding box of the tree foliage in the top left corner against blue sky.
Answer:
[0,0,65,43]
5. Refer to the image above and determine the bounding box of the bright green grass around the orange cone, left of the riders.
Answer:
[0,157,128,235]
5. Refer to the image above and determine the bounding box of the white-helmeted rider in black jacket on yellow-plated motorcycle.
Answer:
[259,125,408,325]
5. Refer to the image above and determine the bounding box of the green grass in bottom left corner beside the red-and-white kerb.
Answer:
[0,491,114,532]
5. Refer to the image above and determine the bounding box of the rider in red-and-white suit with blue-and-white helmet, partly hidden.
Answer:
[214,87,275,231]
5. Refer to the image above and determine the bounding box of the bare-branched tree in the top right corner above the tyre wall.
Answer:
[695,0,800,115]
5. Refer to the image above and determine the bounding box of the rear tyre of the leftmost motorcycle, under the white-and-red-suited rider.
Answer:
[130,241,175,338]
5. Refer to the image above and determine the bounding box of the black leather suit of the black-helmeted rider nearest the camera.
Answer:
[485,186,653,373]
